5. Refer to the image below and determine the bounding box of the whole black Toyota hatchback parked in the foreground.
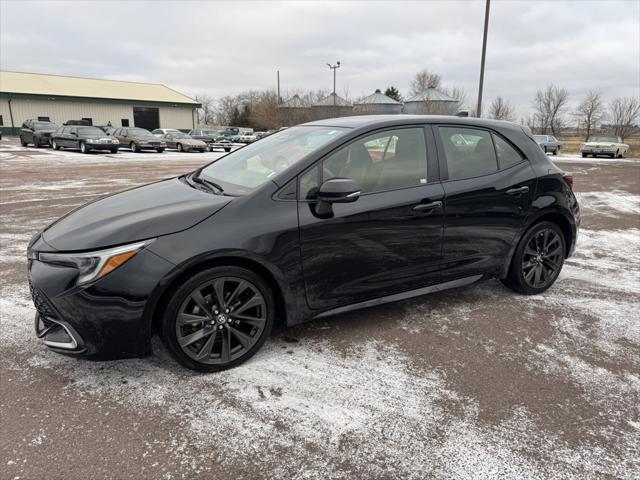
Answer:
[28,115,580,371]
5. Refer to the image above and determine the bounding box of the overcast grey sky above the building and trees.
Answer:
[0,0,640,115]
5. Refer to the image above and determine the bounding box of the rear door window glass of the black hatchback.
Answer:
[438,127,498,180]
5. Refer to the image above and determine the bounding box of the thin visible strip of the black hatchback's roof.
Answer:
[303,115,521,130]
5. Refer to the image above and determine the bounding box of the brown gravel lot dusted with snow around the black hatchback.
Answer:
[0,139,640,479]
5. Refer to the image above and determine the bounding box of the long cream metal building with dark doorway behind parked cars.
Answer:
[0,72,200,134]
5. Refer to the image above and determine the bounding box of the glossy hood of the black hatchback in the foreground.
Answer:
[42,178,232,251]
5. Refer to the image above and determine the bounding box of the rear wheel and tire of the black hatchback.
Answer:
[502,222,566,295]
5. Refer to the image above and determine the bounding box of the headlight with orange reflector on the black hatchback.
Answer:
[37,241,149,285]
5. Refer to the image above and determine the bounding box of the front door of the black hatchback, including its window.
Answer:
[298,126,444,309]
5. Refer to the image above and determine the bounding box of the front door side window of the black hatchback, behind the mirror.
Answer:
[300,128,427,199]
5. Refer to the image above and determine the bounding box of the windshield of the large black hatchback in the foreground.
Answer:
[200,126,347,195]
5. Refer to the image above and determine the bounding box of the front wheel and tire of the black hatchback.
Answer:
[162,266,275,372]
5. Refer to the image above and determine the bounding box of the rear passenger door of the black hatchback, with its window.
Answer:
[435,125,536,281]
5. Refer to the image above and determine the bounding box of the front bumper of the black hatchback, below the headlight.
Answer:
[29,249,174,359]
